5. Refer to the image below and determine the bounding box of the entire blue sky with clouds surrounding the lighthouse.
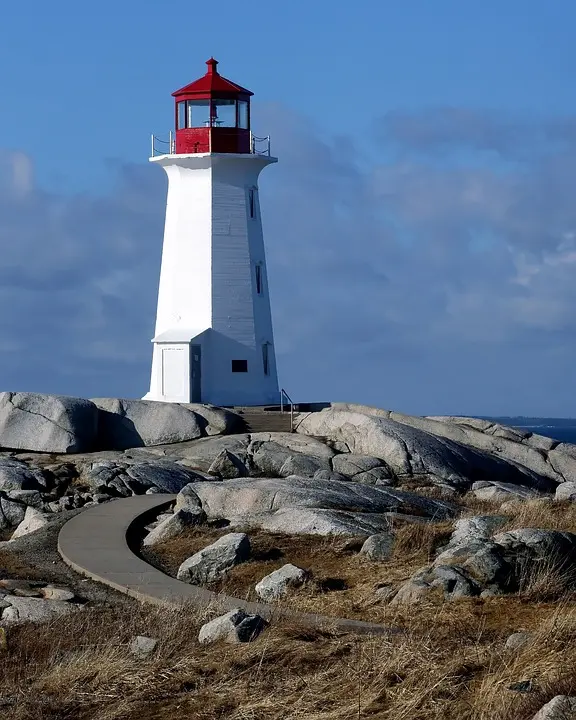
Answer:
[0,0,576,415]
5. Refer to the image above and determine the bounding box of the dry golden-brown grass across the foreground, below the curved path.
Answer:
[0,601,576,720]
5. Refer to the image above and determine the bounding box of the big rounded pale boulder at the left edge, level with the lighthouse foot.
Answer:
[0,392,98,453]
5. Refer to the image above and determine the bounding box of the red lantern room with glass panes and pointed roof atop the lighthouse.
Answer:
[172,58,253,154]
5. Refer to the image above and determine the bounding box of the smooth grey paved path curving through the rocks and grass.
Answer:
[58,494,401,635]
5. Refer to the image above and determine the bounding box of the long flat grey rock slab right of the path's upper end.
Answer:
[187,476,457,535]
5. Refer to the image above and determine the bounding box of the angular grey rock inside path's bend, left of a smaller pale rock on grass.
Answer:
[177,533,250,585]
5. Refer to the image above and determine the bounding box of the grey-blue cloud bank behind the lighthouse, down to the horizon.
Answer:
[0,106,576,415]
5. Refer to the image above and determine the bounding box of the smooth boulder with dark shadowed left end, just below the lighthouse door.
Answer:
[92,398,202,450]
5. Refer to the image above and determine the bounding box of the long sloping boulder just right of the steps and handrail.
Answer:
[296,408,556,490]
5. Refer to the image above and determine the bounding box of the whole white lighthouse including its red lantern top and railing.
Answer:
[145,58,279,406]
